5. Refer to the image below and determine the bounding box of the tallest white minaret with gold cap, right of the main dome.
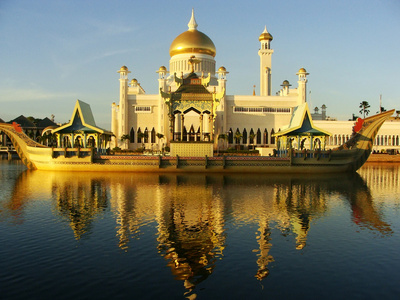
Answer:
[258,26,274,96]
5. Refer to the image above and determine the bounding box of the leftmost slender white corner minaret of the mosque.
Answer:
[117,66,130,148]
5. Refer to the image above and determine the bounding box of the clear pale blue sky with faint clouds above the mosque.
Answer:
[0,0,400,129]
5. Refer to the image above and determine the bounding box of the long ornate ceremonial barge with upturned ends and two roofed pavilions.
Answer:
[0,100,394,173]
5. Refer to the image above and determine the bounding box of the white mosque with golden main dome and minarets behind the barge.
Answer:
[110,10,399,156]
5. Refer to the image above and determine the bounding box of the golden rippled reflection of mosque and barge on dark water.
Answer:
[3,169,398,290]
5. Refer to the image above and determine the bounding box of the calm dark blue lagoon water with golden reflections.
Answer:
[0,161,400,299]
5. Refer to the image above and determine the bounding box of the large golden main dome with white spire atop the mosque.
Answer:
[169,10,217,57]
